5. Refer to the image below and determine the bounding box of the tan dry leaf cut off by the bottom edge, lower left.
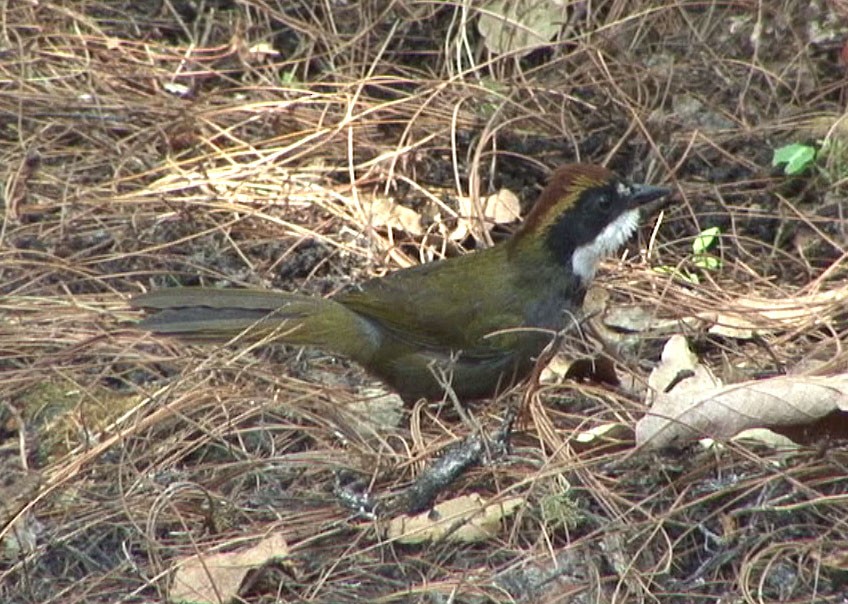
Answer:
[169,535,289,604]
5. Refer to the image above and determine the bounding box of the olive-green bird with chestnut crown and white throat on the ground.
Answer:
[130,163,671,402]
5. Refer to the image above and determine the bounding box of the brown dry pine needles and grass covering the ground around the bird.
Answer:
[0,0,848,604]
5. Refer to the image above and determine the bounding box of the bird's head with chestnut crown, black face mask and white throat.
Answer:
[514,164,670,284]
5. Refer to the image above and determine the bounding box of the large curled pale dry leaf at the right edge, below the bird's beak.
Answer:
[636,336,848,449]
